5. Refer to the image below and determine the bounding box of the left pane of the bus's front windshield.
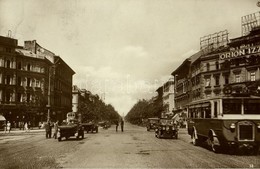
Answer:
[223,99,242,114]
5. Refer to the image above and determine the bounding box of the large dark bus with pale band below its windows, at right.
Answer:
[188,96,260,153]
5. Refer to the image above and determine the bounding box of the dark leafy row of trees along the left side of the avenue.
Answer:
[78,93,120,123]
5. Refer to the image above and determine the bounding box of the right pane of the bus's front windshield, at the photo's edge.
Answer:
[244,100,260,114]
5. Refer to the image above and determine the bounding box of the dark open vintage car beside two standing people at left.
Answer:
[57,122,84,141]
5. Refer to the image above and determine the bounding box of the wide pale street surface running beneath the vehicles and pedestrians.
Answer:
[0,123,260,168]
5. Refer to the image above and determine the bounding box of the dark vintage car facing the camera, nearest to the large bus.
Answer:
[155,118,178,139]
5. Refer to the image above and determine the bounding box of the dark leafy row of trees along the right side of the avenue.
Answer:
[125,98,164,125]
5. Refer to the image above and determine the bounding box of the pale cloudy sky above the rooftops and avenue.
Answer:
[0,0,260,115]
